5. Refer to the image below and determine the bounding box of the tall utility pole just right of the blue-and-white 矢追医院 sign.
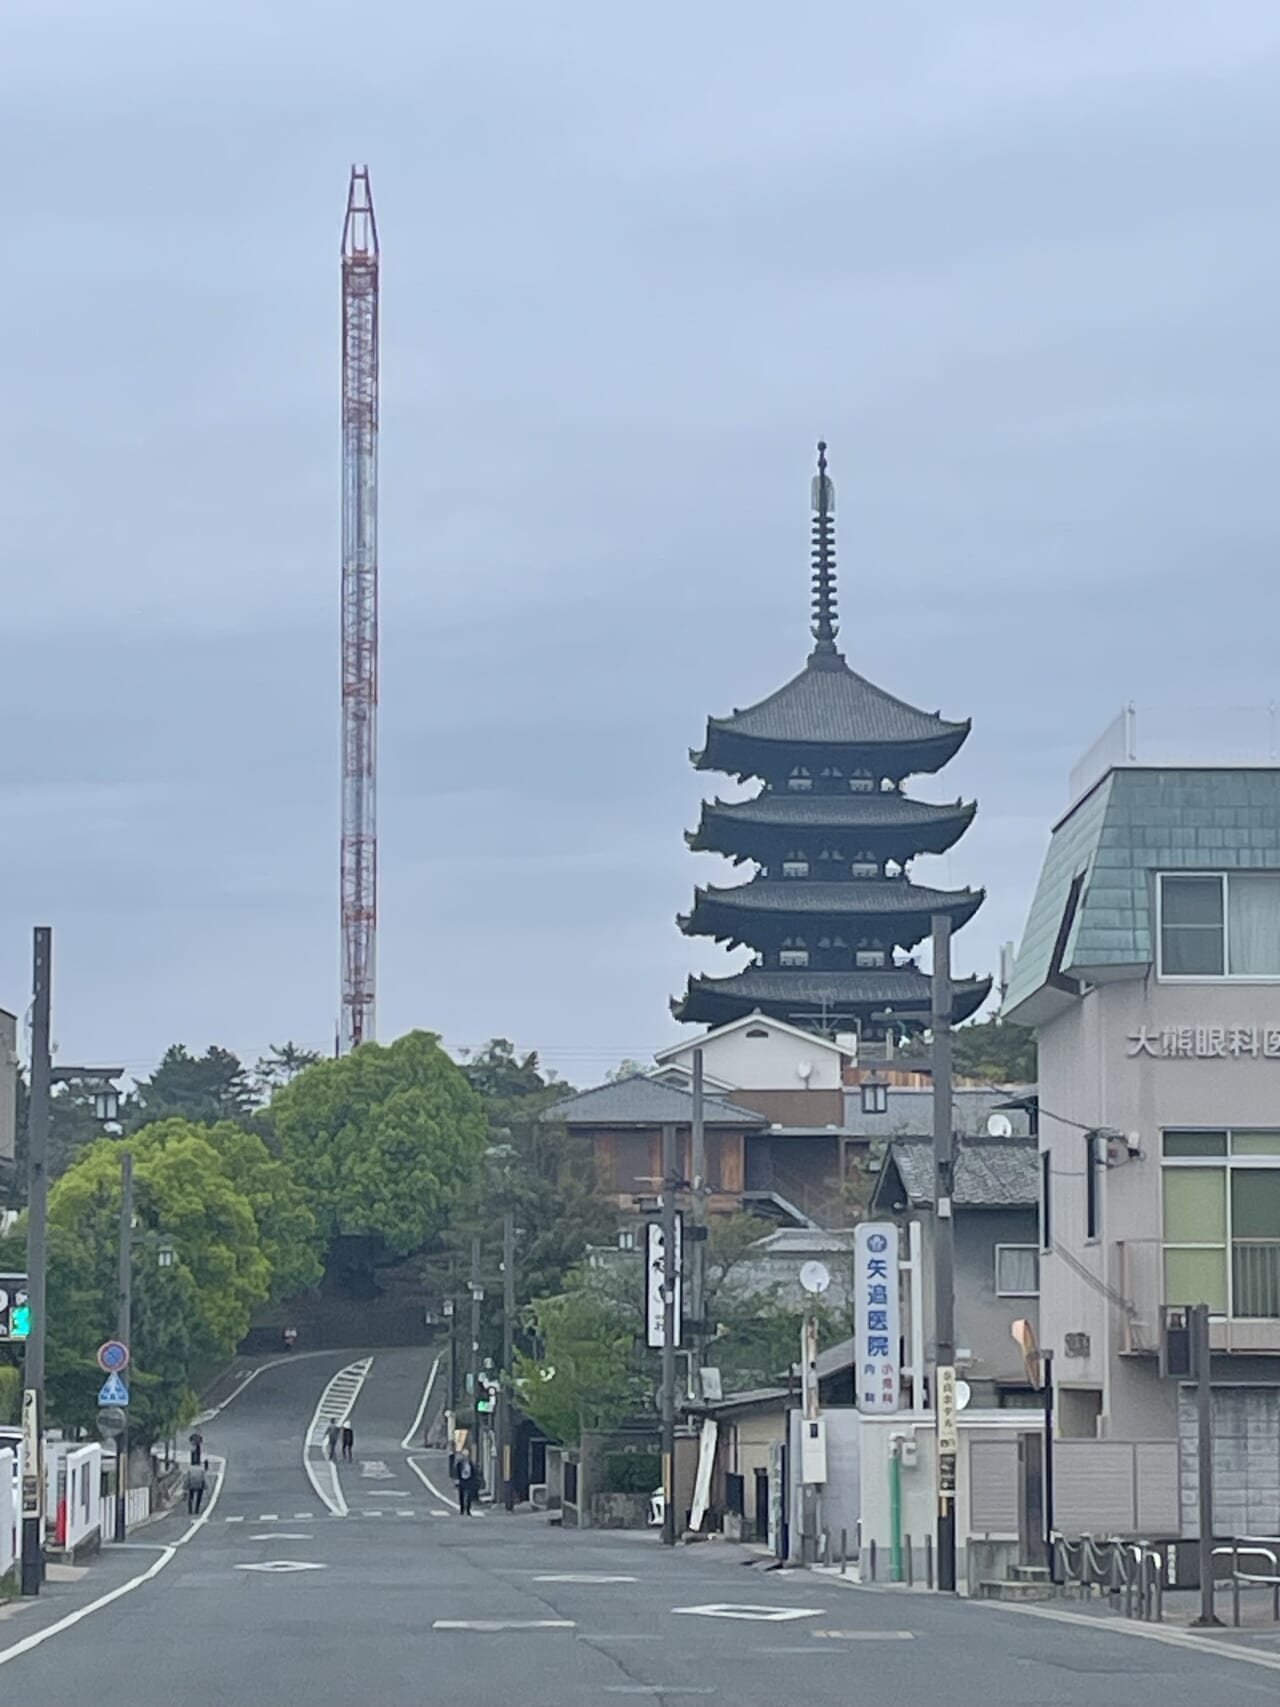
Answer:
[932,913,959,1594]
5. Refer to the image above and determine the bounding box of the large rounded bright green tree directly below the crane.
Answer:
[270,1031,488,1265]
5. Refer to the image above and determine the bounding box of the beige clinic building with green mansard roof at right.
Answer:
[1004,761,1280,1536]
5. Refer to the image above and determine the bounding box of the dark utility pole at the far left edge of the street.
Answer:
[22,925,53,1594]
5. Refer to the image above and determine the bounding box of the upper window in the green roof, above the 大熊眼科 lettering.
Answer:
[1159,871,1280,978]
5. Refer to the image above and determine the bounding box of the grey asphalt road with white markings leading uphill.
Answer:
[0,1352,1280,1707]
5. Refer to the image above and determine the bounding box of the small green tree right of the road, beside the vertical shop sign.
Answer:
[515,1265,654,1446]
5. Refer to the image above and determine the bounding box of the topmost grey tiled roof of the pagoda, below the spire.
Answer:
[691,650,969,775]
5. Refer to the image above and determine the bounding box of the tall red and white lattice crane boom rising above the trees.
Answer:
[338,166,377,1055]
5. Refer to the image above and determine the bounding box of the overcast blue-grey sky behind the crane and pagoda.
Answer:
[0,0,1280,1082]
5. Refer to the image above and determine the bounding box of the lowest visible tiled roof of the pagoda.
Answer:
[671,964,992,1026]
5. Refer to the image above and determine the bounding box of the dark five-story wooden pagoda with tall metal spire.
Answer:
[672,444,992,1038]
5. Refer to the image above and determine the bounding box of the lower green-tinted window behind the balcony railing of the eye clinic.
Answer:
[1162,1130,1280,1318]
